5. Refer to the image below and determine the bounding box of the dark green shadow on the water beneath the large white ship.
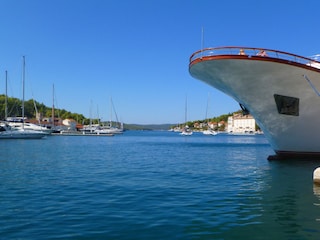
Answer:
[251,159,320,239]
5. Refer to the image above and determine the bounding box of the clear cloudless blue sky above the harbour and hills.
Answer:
[0,0,320,124]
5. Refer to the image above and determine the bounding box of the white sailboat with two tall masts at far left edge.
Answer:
[0,56,47,139]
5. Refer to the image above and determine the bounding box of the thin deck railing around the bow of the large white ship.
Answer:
[190,47,320,68]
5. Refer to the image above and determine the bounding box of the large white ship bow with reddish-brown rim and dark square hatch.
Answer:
[189,47,320,159]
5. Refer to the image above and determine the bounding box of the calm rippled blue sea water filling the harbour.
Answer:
[0,131,320,240]
